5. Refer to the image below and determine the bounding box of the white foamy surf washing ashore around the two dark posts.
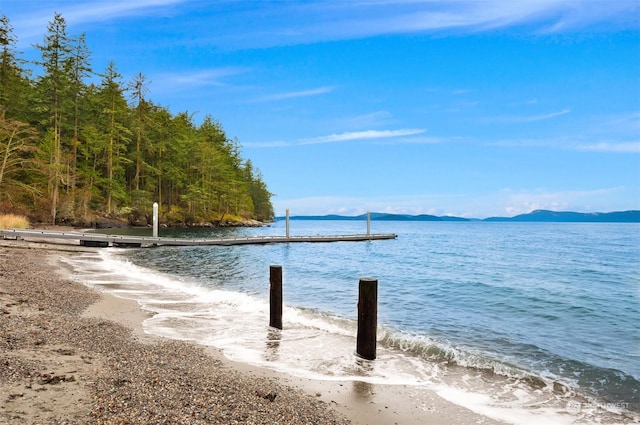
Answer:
[58,249,632,425]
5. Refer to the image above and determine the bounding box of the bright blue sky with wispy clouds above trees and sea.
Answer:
[0,0,640,218]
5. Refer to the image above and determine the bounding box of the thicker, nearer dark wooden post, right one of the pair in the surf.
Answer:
[356,277,378,360]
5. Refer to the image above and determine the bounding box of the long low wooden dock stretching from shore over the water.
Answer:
[0,229,397,248]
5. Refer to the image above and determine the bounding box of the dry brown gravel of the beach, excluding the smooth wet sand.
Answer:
[0,247,350,424]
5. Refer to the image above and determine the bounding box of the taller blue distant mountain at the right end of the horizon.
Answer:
[484,210,640,223]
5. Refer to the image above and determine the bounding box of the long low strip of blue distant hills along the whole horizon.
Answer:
[276,210,640,223]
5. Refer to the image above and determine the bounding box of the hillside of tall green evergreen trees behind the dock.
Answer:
[0,14,274,224]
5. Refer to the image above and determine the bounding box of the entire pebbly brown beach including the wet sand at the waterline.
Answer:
[0,241,508,424]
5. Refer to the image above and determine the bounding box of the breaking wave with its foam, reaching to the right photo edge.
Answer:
[57,250,640,420]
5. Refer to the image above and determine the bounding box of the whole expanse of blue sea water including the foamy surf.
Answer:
[58,221,640,424]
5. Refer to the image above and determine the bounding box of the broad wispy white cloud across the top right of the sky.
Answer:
[234,0,640,44]
